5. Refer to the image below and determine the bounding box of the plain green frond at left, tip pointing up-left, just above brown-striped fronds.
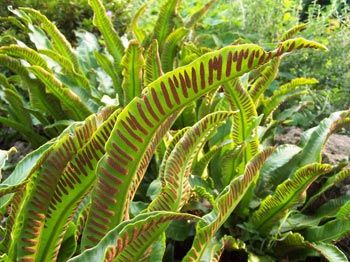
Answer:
[29,66,91,120]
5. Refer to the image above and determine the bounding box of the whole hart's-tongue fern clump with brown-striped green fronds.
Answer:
[0,0,349,261]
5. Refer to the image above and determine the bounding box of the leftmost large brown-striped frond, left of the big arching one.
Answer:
[9,112,105,260]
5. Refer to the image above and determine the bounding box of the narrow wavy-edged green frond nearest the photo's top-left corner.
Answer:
[20,8,80,72]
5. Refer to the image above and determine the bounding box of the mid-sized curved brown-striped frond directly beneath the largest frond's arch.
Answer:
[148,111,233,212]
